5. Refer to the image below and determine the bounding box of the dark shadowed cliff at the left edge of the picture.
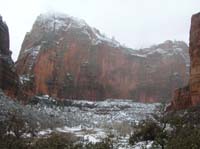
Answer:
[0,16,18,97]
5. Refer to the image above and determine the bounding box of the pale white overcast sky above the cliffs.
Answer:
[0,0,200,60]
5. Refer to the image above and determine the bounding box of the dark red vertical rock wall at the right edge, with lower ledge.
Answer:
[169,13,200,110]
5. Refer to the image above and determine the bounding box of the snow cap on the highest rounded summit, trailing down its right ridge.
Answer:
[36,12,121,47]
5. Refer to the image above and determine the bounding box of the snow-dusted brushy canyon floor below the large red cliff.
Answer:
[0,91,160,149]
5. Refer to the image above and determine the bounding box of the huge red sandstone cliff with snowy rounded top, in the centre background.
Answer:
[16,14,189,102]
